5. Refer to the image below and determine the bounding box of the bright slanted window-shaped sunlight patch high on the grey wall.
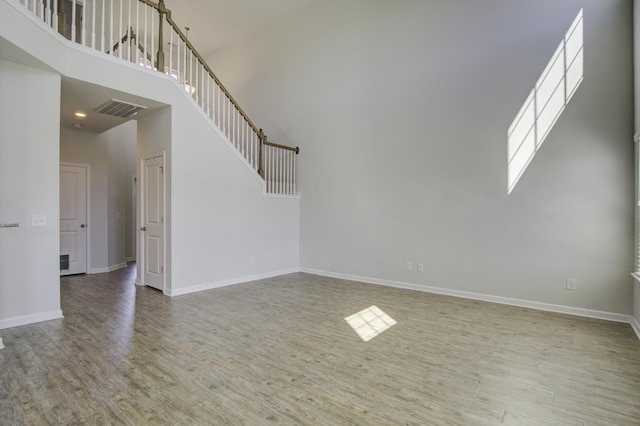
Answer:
[507,9,584,194]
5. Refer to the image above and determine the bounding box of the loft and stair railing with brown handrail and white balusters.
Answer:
[15,0,300,195]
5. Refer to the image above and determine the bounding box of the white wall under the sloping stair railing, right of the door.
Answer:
[171,92,300,294]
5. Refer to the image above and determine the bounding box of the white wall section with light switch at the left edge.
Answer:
[0,60,62,329]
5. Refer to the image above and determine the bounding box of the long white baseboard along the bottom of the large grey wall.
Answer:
[300,268,631,324]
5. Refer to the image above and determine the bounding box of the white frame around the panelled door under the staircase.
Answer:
[135,151,168,294]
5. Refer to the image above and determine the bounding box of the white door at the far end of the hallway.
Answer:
[60,164,87,275]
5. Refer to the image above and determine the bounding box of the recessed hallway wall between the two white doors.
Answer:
[60,121,136,273]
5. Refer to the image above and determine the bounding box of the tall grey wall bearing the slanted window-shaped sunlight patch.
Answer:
[209,0,633,317]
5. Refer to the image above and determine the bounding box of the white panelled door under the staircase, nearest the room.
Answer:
[140,155,164,291]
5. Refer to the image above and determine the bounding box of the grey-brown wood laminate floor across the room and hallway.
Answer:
[0,266,640,425]
